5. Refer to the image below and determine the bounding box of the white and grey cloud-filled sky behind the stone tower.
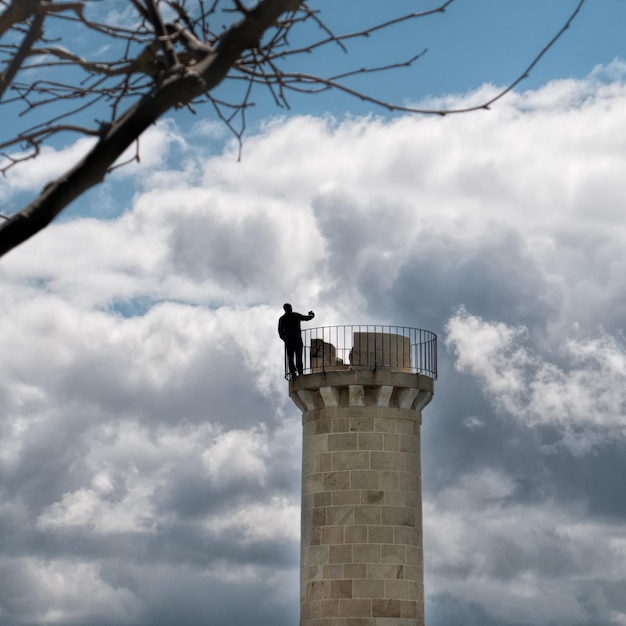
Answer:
[0,0,626,626]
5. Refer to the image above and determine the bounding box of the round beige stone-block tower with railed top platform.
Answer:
[289,326,437,626]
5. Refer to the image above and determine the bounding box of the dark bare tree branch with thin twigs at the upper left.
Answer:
[0,0,586,255]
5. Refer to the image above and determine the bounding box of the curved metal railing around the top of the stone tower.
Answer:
[285,324,437,380]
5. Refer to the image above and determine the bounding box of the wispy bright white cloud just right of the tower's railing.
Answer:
[446,310,626,451]
